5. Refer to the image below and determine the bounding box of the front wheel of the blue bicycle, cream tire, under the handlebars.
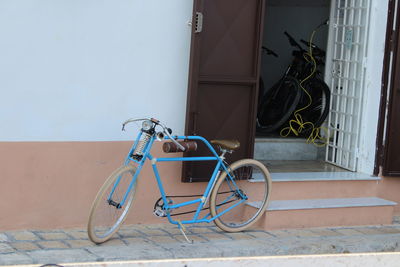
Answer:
[88,165,136,243]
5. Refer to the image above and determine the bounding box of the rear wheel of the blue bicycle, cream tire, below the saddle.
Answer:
[210,159,271,232]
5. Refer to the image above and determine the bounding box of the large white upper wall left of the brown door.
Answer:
[0,0,193,141]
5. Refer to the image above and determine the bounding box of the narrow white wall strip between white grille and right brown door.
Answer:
[358,0,388,173]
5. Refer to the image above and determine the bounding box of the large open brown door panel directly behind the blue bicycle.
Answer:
[183,0,264,181]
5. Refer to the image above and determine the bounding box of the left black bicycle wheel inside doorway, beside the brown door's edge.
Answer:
[257,76,301,133]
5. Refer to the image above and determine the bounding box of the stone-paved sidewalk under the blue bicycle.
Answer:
[0,217,400,265]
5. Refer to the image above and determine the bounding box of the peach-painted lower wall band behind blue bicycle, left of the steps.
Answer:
[0,142,209,230]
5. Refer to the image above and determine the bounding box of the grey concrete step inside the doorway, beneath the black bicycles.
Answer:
[254,138,325,160]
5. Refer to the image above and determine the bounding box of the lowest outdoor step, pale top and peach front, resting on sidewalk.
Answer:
[246,197,397,229]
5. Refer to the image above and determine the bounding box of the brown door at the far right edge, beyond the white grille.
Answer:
[375,0,400,177]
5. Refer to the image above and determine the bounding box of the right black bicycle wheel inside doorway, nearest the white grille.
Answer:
[299,78,331,136]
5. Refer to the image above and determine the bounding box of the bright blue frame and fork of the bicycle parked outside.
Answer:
[108,131,247,225]
